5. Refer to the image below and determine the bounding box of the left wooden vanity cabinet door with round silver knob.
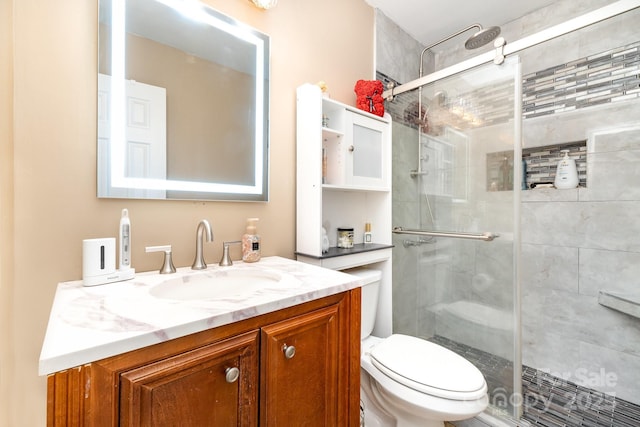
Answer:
[120,331,259,427]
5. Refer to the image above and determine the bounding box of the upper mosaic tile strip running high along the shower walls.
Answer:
[377,41,640,128]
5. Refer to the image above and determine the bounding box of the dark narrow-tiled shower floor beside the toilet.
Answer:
[429,335,640,427]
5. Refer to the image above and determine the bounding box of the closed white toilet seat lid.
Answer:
[370,334,487,400]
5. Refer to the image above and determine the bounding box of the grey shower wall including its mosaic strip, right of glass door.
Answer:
[521,2,640,404]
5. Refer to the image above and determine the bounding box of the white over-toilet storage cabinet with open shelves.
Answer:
[296,84,392,280]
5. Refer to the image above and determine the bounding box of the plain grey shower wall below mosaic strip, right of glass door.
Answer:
[521,110,640,403]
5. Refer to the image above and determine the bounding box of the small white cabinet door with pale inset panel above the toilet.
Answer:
[345,112,390,188]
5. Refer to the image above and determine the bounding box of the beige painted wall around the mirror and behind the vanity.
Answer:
[0,0,374,426]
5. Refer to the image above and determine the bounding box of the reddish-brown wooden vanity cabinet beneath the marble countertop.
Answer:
[47,289,360,427]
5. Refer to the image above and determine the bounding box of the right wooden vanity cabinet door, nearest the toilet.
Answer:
[260,305,347,427]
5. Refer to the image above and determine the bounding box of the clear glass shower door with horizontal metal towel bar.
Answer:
[390,58,521,417]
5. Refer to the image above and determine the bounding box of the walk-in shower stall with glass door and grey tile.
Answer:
[378,0,640,426]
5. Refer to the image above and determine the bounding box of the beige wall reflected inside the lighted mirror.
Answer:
[109,30,255,183]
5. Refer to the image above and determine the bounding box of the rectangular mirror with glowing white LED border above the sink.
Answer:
[97,0,269,201]
